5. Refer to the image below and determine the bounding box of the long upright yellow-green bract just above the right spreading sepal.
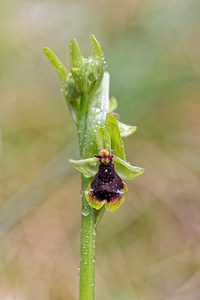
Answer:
[105,113,126,160]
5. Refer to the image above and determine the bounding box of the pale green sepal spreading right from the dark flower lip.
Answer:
[113,156,144,180]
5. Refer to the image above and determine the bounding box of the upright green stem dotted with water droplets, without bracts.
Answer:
[79,94,96,300]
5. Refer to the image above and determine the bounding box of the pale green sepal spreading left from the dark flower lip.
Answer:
[69,157,99,177]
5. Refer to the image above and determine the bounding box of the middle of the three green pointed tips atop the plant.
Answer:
[69,39,87,94]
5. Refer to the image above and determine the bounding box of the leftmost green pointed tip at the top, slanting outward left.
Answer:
[43,47,68,84]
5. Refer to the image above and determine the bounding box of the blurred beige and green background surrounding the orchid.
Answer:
[0,0,200,300]
